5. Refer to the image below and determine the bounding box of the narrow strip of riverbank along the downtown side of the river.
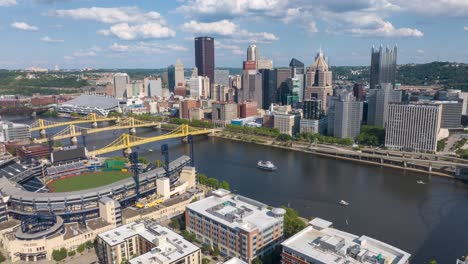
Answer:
[215,133,455,179]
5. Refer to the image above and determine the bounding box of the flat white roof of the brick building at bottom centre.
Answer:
[187,189,282,232]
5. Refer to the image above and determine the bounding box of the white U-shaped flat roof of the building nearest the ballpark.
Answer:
[99,219,199,264]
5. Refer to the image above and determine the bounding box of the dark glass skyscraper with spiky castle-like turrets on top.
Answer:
[369,45,397,89]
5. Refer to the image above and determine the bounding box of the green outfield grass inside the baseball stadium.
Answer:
[49,171,132,192]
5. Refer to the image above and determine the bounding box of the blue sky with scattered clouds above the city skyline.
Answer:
[0,0,468,69]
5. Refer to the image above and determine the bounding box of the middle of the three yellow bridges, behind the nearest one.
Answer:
[33,117,161,143]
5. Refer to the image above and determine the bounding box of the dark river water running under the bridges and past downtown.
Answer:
[7,116,468,263]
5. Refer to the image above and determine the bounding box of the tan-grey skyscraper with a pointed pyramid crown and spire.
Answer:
[304,49,333,114]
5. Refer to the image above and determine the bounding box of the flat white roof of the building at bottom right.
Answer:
[282,218,411,264]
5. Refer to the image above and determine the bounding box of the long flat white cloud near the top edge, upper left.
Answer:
[48,7,165,24]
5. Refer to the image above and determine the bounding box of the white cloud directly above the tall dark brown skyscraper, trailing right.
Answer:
[182,19,278,43]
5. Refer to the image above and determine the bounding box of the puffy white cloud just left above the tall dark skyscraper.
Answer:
[103,23,176,40]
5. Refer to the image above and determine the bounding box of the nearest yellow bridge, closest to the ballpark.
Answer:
[88,125,216,156]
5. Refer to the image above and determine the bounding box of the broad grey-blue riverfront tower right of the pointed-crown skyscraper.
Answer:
[328,91,363,139]
